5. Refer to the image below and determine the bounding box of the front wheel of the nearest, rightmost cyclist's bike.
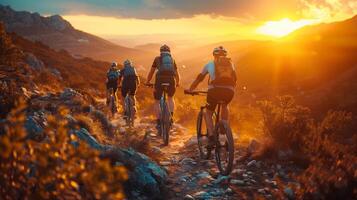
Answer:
[196,110,211,159]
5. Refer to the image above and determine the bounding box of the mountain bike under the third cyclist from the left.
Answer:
[146,83,172,146]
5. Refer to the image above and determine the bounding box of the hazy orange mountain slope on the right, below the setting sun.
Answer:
[236,16,357,112]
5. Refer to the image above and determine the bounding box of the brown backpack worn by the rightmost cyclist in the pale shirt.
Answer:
[211,56,236,87]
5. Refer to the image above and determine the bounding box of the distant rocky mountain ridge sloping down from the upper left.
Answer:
[0,5,144,61]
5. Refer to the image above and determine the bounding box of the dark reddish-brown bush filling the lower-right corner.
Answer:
[297,111,357,199]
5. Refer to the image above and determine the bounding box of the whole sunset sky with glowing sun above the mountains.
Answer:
[0,0,357,45]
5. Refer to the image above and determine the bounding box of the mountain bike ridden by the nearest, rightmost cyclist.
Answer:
[185,90,234,175]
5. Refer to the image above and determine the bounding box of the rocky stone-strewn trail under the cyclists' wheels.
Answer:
[109,113,296,199]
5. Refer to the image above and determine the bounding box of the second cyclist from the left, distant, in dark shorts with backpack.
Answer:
[119,60,140,116]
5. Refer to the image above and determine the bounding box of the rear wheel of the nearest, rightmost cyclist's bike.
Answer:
[215,121,234,176]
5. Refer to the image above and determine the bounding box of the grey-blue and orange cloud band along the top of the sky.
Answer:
[0,0,357,21]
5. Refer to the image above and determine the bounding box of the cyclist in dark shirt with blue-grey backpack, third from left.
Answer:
[146,45,180,127]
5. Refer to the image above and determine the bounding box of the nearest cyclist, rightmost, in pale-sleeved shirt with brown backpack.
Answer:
[188,46,237,144]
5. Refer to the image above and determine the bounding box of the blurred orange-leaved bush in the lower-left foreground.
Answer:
[0,104,127,199]
